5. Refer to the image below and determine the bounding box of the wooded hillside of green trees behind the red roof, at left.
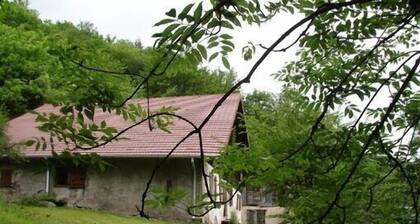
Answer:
[0,2,235,117]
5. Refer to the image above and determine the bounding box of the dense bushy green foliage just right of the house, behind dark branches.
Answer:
[216,90,418,223]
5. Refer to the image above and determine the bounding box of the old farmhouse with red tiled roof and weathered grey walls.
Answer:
[0,93,247,224]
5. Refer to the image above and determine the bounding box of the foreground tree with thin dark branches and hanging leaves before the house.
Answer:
[4,0,420,223]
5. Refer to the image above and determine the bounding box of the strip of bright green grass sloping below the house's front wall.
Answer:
[0,195,182,224]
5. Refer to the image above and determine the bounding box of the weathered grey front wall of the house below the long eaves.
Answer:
[0,158,202,220]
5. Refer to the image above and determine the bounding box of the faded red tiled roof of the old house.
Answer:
[7,94,240,157]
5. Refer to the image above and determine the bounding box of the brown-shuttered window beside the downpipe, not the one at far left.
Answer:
[55,167,86,188]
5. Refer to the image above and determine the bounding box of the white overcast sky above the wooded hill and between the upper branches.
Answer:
[29,0,300,93]
